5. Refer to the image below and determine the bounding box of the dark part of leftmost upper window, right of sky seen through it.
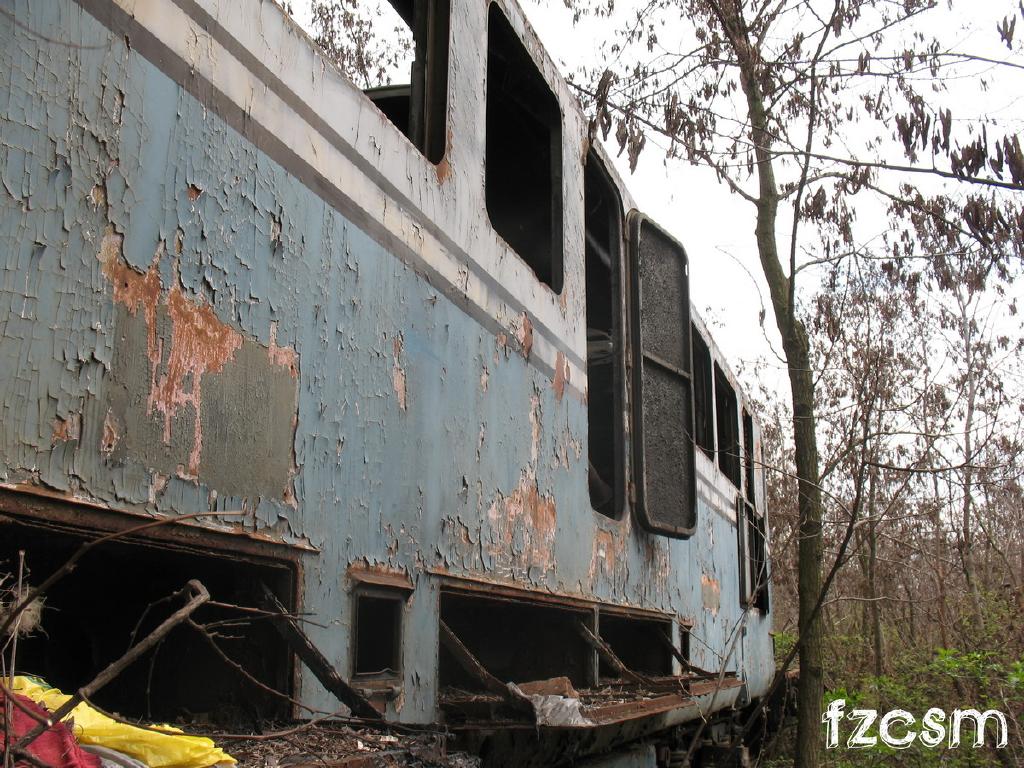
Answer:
[365,0,451,164]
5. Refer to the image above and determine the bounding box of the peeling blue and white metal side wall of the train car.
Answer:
[0,0,771,721]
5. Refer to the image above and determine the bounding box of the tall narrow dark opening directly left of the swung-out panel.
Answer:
[584,152,625,518]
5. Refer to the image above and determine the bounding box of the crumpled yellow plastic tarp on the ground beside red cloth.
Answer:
[13,676,237,768]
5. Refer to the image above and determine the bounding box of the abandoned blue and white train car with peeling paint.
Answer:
[0,0,774,765]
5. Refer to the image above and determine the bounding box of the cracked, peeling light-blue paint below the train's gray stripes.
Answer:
[0,0,773,722]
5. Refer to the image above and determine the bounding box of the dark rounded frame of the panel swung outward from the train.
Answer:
[627,210,697,539]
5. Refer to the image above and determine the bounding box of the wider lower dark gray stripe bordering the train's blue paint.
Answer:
[75,0,583,397]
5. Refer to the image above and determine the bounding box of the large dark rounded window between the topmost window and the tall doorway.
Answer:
[484,4,562,294]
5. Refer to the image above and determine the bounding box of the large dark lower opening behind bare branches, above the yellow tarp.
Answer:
[0,521,294,728]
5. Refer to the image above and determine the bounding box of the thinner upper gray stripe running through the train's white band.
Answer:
[167,0,586,370]
